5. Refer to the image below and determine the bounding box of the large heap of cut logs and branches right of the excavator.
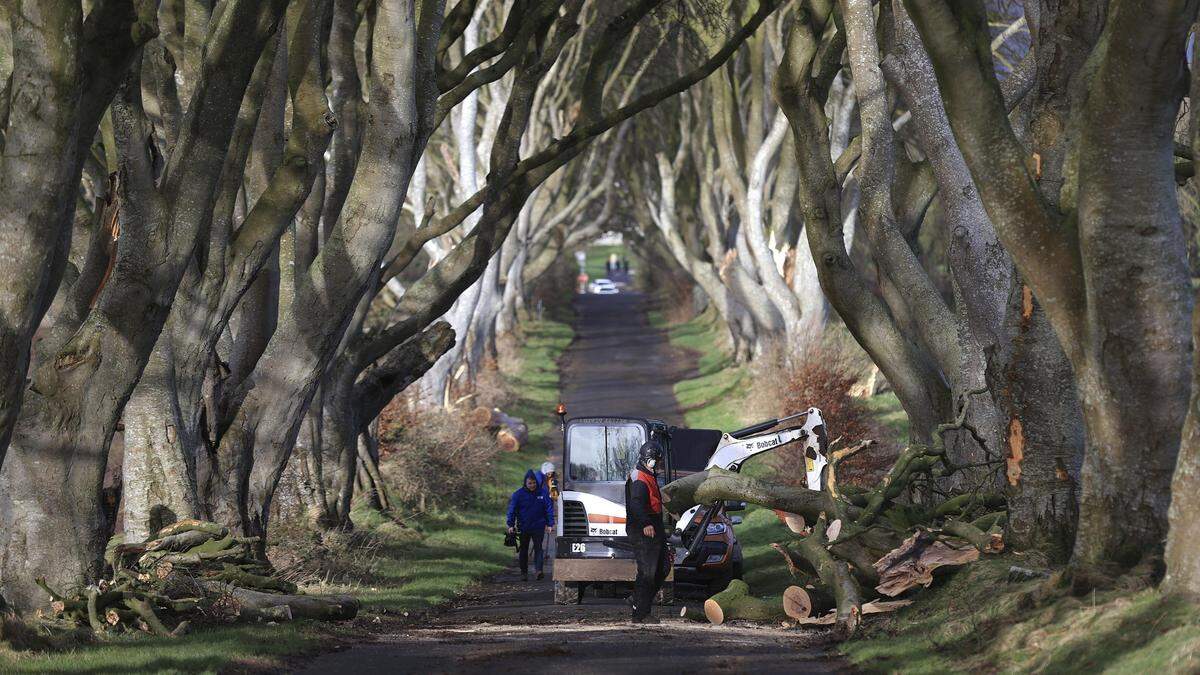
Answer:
[662,393,1006,639]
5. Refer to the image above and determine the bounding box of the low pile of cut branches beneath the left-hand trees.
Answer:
[37,520,358,637]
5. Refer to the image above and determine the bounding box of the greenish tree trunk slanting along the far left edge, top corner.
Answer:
[0,1,156,465]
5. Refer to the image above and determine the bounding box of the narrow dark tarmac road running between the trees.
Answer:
[304,293,846,675]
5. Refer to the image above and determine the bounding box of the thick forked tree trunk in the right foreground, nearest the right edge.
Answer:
[905,0,1196,576]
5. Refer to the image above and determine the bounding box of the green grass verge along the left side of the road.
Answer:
[0,321,571,673]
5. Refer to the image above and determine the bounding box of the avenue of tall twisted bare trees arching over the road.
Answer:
[0,0,1200,609]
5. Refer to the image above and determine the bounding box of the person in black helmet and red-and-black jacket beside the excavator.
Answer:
[625,441,671,623]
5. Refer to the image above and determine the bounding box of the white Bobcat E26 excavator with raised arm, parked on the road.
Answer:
[553,406,828,604]
